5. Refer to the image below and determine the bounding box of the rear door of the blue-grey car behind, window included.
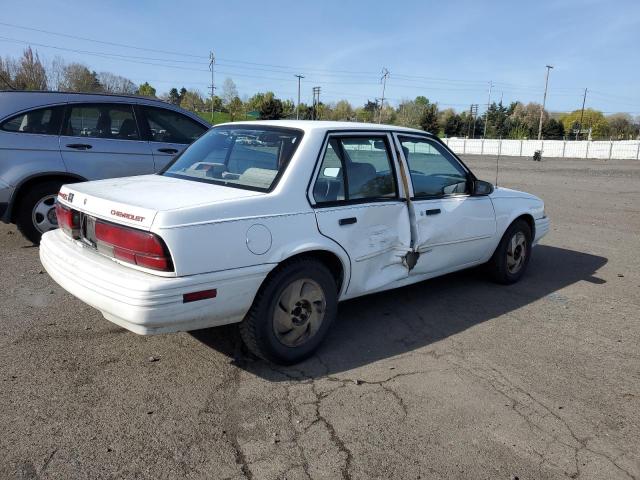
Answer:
[60,103,154,180]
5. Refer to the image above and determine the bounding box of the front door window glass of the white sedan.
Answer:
[400,137,469,197]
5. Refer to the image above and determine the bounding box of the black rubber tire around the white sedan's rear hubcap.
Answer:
[240,258,338,365]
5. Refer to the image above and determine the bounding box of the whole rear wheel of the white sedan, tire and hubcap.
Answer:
[240,259,338,364]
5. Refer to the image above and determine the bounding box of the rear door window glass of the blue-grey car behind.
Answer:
[64,103,140,140]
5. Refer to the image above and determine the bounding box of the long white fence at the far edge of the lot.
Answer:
[442,138,640,160]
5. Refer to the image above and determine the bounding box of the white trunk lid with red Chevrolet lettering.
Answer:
[59,175,264,230]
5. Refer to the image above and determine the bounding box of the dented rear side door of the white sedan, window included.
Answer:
[309,132,411,297]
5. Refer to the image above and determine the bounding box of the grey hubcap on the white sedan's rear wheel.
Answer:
[273,278,326,347]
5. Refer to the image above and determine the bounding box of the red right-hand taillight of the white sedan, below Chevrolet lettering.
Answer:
[96,221,173,272]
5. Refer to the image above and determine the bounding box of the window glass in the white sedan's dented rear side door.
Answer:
[313,136,397,204]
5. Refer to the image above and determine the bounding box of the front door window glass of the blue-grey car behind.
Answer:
[142,107,207,144]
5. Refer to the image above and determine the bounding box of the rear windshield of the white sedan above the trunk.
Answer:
[162,125,302,192]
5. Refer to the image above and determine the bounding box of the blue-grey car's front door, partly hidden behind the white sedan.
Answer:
[139,105,207,171]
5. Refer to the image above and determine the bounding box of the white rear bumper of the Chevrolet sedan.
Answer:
[40,230,273,335]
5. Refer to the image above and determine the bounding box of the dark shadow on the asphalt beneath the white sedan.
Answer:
[191,245,607,381]
